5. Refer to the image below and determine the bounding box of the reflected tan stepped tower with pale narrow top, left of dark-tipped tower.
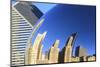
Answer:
[49,40,59,63]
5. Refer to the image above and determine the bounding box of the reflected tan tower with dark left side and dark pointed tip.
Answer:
[59,33,76,63]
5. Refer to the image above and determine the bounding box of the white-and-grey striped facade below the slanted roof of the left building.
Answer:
[11,7,32,66]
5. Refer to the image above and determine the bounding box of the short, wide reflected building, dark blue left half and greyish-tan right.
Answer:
[75,46,87,57]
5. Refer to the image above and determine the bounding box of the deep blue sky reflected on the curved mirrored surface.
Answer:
[33,3,95,55]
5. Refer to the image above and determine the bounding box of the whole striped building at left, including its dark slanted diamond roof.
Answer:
[11,2,42,66]
